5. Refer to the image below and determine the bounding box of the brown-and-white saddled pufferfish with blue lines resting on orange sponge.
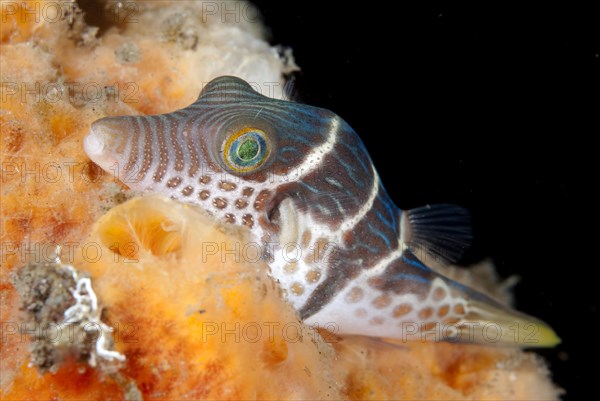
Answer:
[84,76,560,346]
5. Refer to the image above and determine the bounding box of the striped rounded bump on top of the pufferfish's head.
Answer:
[197,75,264,103]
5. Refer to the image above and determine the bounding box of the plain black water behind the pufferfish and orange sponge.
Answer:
[254,1,600,400]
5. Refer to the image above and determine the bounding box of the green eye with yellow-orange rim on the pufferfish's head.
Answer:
[223,128,270,173]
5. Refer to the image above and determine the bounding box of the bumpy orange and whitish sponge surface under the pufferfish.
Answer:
[0,1,558,400]
